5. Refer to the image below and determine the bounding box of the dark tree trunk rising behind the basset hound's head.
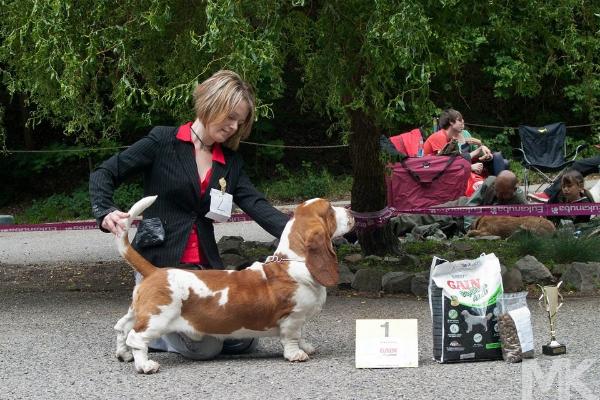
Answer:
[350,110,403,256]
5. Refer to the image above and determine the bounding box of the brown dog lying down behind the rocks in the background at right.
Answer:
[467,215,556,239]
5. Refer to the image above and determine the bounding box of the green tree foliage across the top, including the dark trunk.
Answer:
[0,0,600,253]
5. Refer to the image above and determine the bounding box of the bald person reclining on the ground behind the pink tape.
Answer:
[390,170,527,236]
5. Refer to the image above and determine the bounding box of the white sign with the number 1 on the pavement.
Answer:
[356,319,419,368]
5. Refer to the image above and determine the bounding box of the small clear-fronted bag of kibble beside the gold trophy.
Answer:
[498,292,533,363]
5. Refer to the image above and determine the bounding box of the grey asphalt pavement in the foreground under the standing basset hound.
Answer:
[0,291,600,400]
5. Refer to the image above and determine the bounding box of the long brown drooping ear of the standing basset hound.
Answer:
[305,226,340,286]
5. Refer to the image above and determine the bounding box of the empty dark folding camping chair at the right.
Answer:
[515,122,585,194]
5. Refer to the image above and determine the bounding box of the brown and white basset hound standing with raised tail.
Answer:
[115,196,354,374]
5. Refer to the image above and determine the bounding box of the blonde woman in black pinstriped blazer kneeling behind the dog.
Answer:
[90,70,288,359]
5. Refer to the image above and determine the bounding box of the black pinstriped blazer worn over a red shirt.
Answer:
[90,126,289,269]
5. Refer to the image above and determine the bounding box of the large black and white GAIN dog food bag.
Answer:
[429,254,503,363]
